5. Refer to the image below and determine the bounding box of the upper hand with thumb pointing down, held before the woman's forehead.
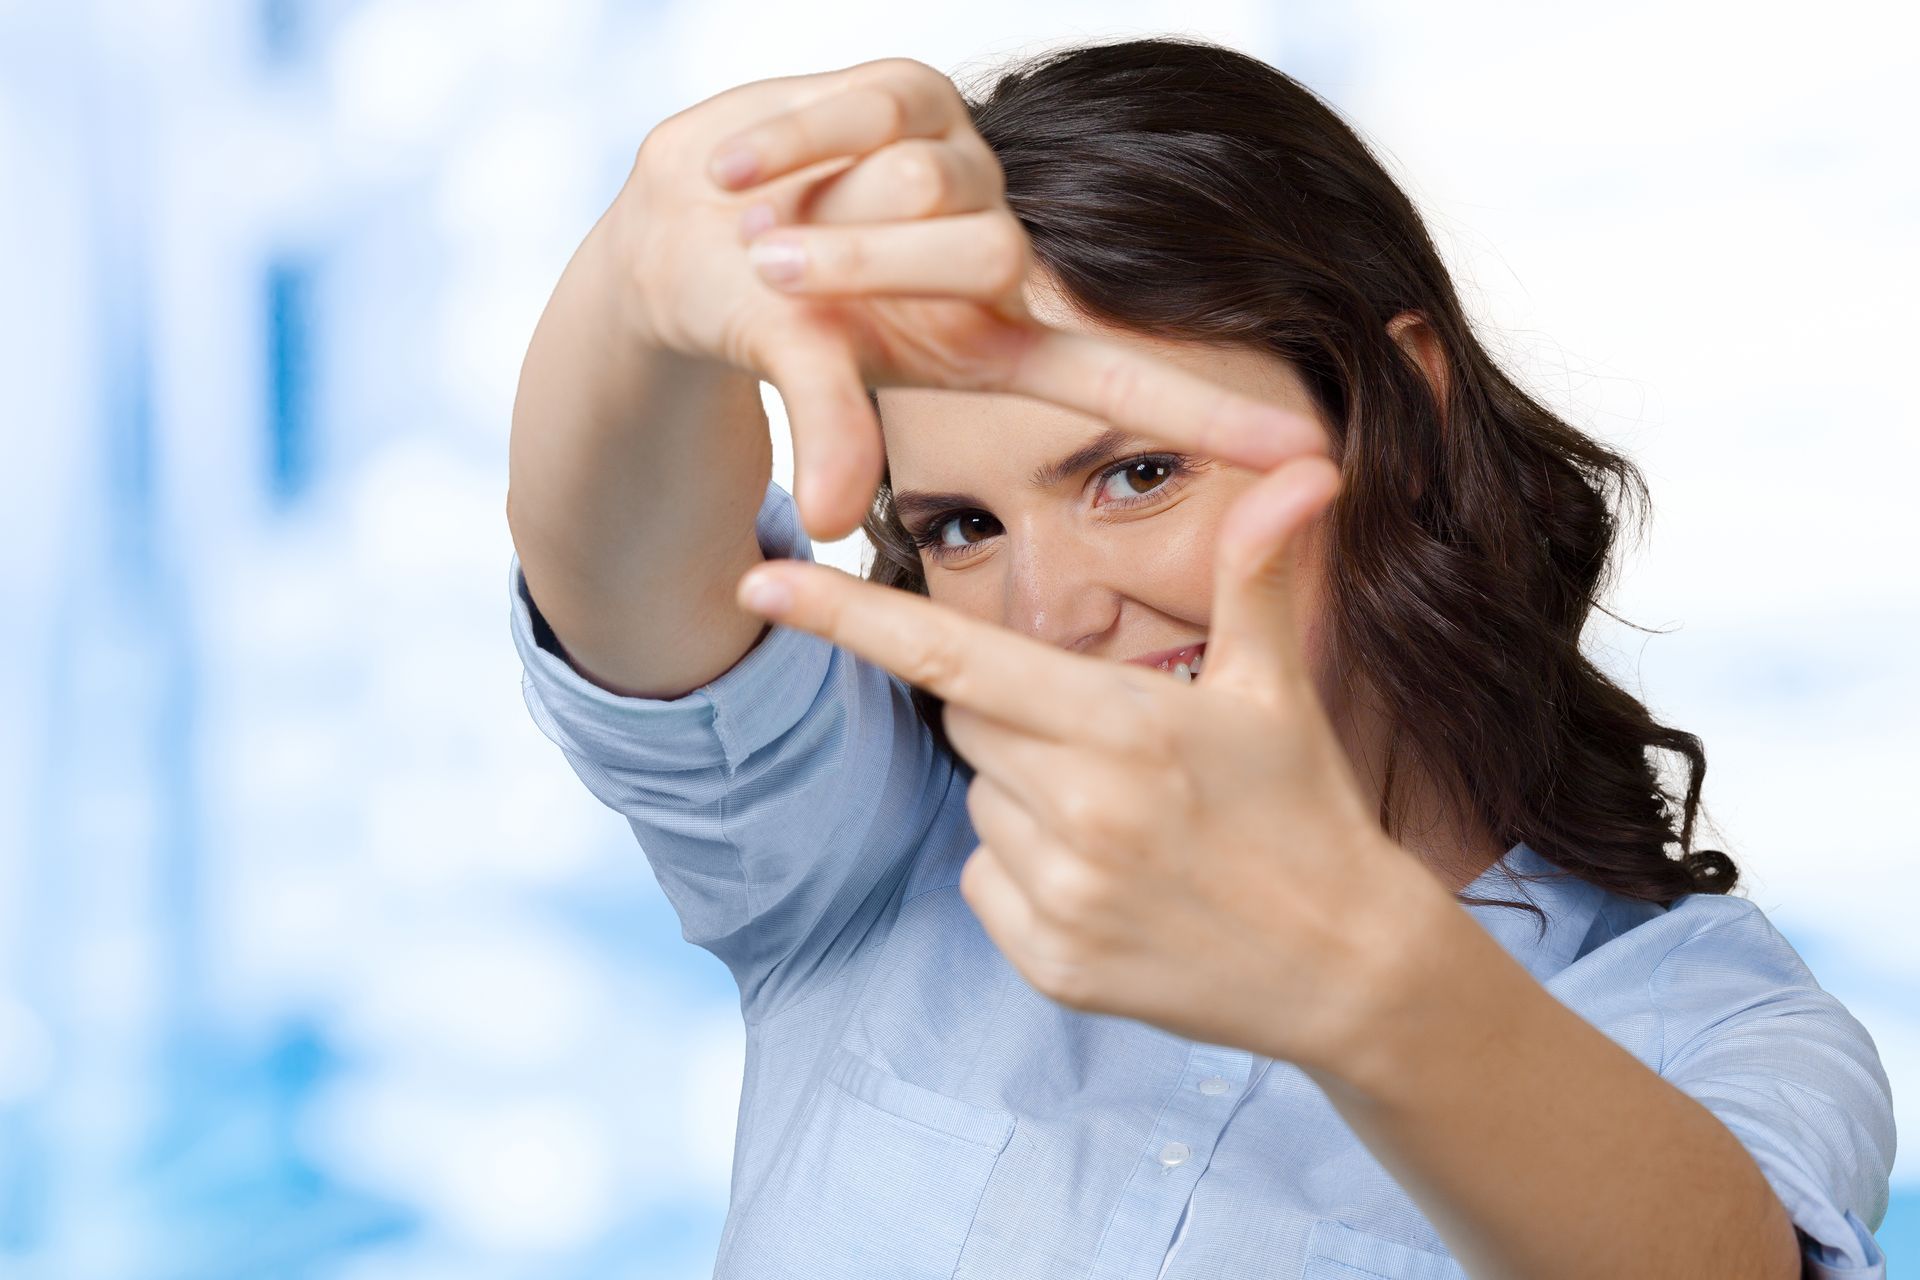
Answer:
[612,58,1327,539]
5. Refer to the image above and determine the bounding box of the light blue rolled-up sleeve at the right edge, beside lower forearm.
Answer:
[1649,896,1895,1278]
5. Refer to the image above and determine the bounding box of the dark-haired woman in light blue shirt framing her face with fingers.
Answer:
[509,38,1893,1280]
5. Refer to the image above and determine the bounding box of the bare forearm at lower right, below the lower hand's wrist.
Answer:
[1309,875,1801,1280]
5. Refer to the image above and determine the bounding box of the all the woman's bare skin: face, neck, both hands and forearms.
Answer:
[509,50,1799,1280]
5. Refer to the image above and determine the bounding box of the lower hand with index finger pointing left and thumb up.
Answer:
[737,455,1452,1075]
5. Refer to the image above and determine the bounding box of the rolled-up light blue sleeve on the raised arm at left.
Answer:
[509,484,952,1021]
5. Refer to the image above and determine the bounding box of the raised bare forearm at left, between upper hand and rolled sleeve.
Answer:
[507,213,772,697]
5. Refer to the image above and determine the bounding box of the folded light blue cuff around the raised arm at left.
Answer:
[507,482,833,770]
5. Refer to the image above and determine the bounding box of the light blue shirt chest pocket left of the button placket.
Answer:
[716,1048,1014,1280]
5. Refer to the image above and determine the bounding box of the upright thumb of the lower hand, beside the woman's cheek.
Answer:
[1202,453,1340,702]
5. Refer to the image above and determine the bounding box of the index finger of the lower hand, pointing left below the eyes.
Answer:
[735,560,1164,743]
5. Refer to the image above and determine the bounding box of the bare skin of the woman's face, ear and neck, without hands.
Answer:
[877,269,1505,890]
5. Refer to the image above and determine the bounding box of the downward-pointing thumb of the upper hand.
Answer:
[760,324,885,541]
